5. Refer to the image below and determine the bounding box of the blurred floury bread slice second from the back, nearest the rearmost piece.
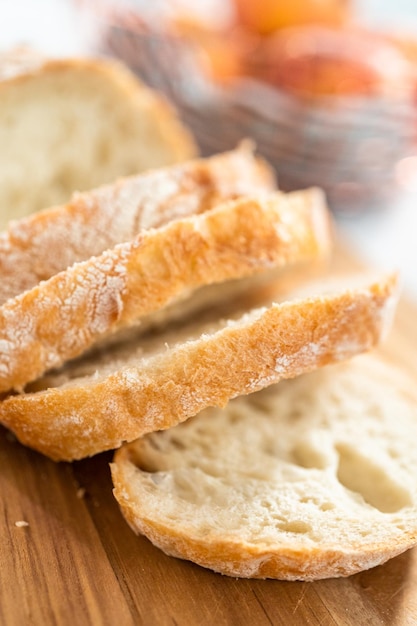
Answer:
[0,142,276,304]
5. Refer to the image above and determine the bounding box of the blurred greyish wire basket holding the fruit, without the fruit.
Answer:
[80,1,417,212]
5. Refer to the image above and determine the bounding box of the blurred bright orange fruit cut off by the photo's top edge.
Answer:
[234,0,351,35]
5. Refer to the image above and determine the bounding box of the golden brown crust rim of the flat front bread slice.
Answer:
[111,472,417,581]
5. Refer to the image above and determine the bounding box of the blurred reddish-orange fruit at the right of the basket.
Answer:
[250,25,414,97]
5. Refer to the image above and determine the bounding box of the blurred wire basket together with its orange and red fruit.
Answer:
[83,0,417,212]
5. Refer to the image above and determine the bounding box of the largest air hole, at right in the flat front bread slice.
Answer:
[336,444,412,513]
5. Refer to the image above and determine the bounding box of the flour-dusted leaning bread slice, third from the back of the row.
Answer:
[0,189,331,391]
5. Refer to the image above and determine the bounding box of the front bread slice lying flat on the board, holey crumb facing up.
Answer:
[111,355,417,580]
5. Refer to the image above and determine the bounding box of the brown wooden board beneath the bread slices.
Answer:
[0,246,417,626]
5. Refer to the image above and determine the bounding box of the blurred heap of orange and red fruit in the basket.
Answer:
[170,0,417,97]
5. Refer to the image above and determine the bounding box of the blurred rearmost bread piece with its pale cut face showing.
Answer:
[0,50,197,228]
